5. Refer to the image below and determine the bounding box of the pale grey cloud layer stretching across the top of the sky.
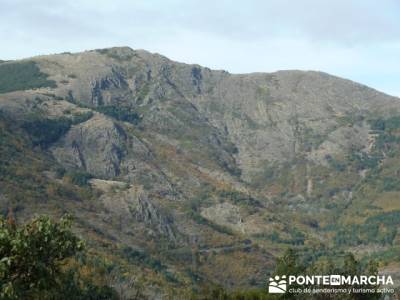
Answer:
[0,0,400,45]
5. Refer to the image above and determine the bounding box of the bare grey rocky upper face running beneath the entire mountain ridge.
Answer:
[28,48,399,181]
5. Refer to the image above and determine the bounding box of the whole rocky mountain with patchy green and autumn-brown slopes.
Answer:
[0,47,400,297]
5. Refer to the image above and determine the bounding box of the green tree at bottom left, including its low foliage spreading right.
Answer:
[0,216,116,299]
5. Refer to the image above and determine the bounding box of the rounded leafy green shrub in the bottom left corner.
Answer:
[0,217,83,299]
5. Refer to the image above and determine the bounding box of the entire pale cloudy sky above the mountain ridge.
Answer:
[0,0,400,96]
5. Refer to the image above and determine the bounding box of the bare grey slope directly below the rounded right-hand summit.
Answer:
[187,71,398,179]
